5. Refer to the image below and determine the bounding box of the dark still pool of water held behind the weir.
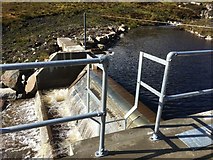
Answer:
[109,27,213,119]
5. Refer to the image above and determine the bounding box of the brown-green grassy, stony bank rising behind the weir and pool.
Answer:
[1,3,211,63]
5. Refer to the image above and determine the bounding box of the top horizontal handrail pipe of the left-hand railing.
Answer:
[0,56,105,71]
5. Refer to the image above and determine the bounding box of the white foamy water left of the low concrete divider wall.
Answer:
[0,98,40,159]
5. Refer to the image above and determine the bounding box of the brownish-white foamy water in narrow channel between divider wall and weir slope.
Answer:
[41,88,82,158]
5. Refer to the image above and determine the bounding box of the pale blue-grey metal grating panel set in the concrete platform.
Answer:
[176,124,213,149]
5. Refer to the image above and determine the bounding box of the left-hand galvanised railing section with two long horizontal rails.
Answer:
[0,56,109,157]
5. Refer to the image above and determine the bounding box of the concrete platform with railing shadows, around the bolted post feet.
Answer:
[67,111,213,159]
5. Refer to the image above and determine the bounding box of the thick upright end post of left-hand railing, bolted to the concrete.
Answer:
[95,57,109,157]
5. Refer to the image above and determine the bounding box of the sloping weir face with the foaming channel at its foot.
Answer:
[38,71,154,157]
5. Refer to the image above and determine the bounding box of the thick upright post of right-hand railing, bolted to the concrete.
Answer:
[151,56,171,141]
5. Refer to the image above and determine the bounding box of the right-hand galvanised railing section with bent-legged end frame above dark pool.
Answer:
[125,50,213,140]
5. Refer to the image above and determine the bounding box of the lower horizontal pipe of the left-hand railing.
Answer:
[0,112,105,134]
